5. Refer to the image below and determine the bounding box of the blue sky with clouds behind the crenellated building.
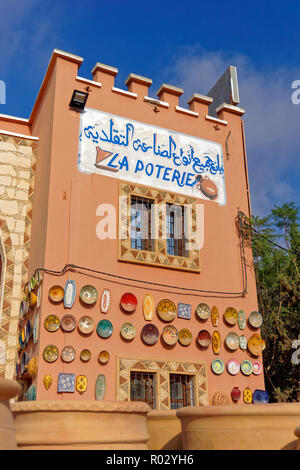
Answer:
[0,0,300,216]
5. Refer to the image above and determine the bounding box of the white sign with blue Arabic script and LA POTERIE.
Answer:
[78,108,226,205]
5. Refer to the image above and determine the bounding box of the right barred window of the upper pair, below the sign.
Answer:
[166,204,188,257]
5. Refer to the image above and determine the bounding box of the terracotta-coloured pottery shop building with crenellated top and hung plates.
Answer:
[0,50,264,410]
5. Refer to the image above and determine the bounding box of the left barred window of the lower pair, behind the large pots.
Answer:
[130,372,156,409]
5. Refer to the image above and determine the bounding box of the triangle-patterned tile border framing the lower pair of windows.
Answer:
[117,357,208,410]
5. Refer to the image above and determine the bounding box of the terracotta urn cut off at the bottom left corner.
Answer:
[0,378,21,450]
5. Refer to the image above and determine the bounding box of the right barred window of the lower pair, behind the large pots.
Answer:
[170,374,195,410]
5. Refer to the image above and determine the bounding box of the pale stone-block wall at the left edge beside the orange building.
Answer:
[0,133,37,379]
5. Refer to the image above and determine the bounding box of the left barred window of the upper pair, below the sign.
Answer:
[130,196,154,251]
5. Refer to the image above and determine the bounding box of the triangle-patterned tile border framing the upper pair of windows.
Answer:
[119,182,201,272]
